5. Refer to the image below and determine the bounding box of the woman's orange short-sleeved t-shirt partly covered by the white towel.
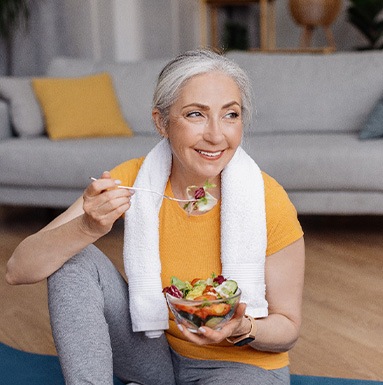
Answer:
[111,158,303,369]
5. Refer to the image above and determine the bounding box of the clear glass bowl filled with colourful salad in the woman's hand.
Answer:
[163,274,241,331]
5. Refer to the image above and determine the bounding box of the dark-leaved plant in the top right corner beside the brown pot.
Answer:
[347,0,383,50]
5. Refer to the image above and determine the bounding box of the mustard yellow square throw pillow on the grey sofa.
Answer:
[32,73,133,139]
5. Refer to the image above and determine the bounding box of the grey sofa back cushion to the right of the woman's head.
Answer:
[228,51,383,133]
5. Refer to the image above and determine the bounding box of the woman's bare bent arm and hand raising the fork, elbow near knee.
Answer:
[6,173,132,284]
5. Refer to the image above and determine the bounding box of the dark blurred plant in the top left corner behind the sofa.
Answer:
[0,0,30,75]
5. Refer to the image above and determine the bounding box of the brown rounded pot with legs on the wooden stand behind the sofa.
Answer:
[289,0,342,49]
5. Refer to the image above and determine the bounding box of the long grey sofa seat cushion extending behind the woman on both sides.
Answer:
[0,134,383,192]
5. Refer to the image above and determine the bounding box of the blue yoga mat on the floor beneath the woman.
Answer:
[0,343,383,385]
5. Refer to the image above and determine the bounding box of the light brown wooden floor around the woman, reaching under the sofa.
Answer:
[0,208,383,380]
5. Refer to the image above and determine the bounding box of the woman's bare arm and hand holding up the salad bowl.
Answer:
[177,234,305,352]
